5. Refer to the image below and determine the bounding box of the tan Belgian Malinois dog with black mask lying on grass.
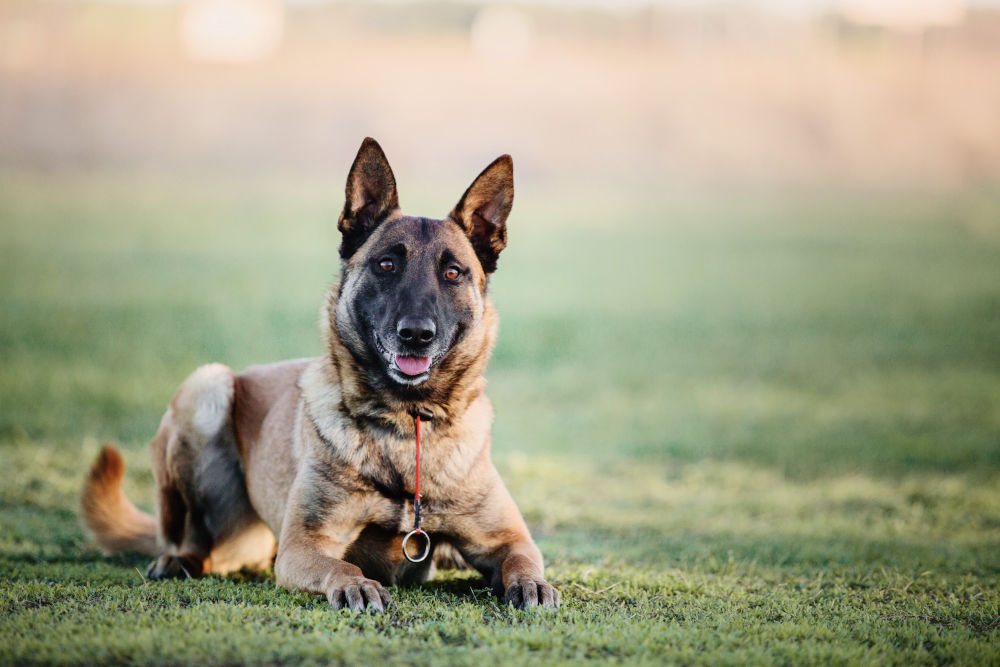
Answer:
[81,138,559,612]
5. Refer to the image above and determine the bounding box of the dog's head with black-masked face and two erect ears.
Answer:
[335,138,514,393]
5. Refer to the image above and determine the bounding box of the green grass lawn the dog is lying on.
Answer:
[0,173,1000,665]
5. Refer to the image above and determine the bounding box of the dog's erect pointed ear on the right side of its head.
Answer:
[450,155,514,273]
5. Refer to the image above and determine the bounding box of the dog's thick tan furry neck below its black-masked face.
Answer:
[320,285,497,433]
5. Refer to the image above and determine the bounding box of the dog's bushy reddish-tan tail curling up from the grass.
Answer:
[80,445,159,556]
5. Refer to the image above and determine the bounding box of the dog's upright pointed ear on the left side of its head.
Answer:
[337,137,399,259]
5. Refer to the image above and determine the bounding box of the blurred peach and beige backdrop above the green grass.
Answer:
[0,0,1000,191]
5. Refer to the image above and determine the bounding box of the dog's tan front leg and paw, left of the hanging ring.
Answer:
[274,482,391,613]
